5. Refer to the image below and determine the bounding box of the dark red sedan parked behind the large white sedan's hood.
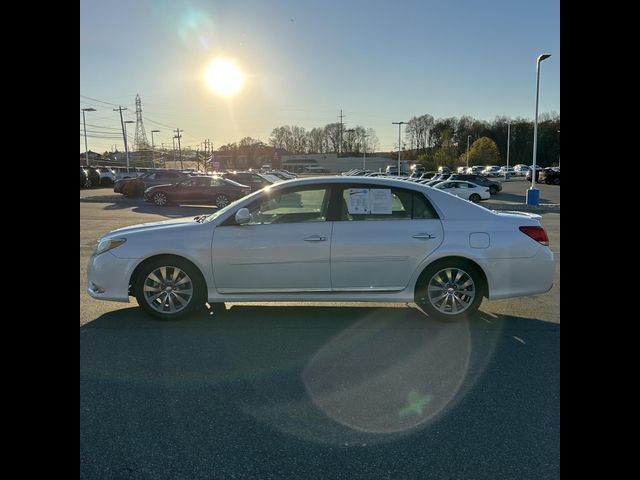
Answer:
[144,176,251,208]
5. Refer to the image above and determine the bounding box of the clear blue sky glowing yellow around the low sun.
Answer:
[80,0,560,152]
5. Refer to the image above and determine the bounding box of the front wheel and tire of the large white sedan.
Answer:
[134,257,207,320]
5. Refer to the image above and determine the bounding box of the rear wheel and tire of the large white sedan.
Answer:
[415,259,486,321]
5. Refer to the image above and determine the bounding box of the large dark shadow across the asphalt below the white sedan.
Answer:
[80,306,560,479]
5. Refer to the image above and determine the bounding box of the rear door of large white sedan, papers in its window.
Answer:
[331,184,443,292]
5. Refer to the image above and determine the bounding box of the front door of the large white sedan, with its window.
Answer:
[211,185,332,293]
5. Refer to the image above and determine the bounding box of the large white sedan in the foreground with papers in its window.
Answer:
[88,176,555,319]
